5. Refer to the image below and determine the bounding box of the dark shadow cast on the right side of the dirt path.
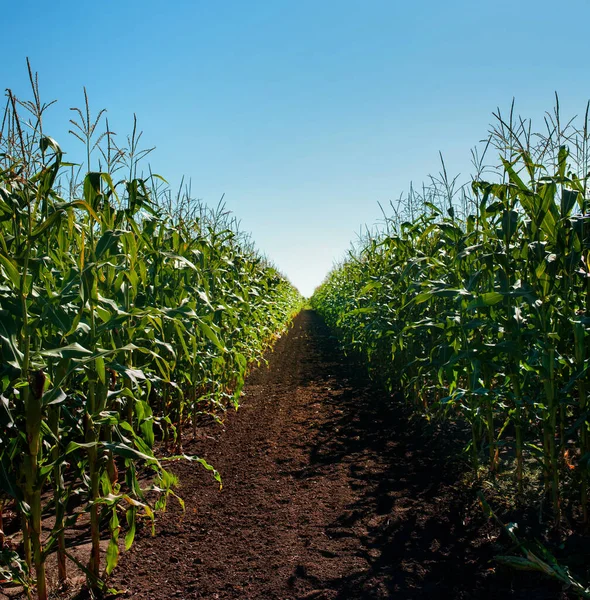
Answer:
[292,319,567,600]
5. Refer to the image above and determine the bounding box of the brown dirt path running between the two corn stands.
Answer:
[111,311,561,600]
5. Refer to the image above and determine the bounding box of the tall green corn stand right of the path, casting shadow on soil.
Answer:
[312,99,590,525]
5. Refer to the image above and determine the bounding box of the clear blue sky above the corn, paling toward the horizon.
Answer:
[0,0,590,295]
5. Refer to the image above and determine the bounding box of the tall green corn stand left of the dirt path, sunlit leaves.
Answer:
[0,72,301,600]
